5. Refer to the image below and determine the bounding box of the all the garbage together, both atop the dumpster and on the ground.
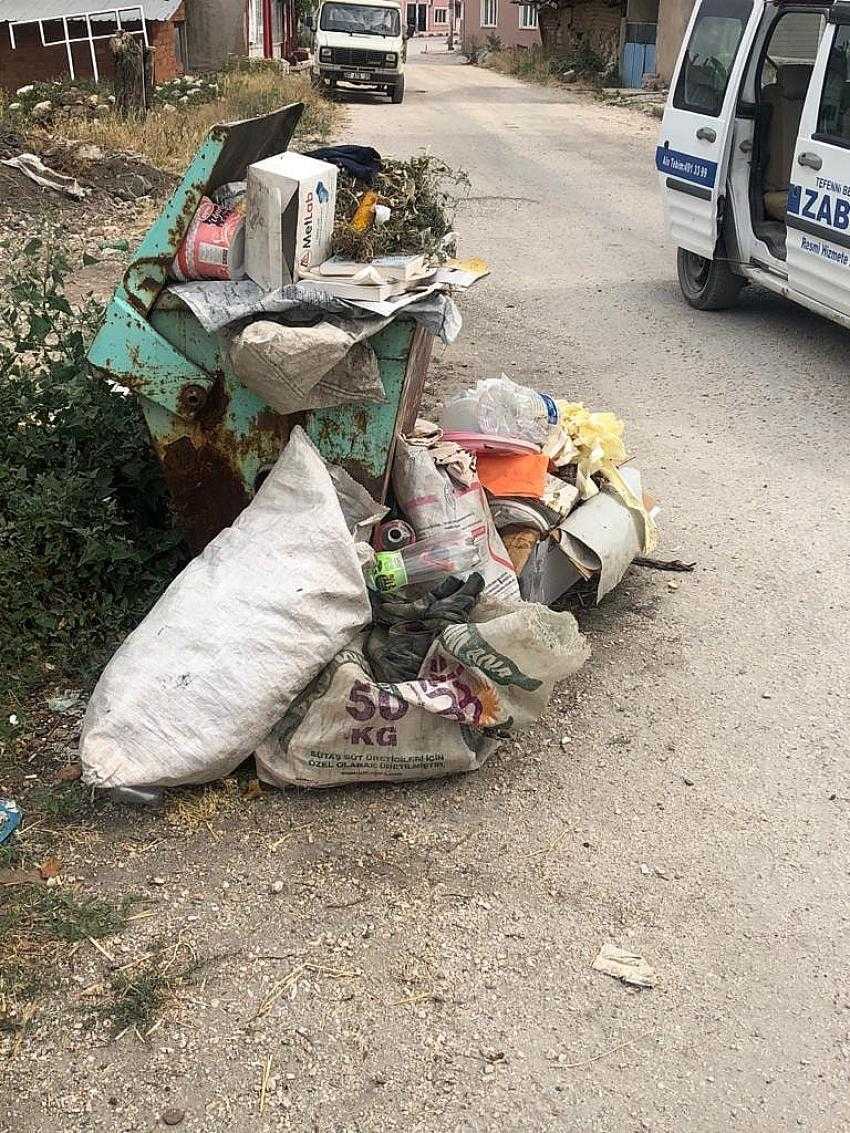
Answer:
[80,130,656,798]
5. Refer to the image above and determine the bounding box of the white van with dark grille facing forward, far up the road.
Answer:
[308,0,407,102]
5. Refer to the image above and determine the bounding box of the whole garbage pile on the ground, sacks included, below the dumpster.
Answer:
[80,377,655,789]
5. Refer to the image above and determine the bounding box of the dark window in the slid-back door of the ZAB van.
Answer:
[673,0,753,118]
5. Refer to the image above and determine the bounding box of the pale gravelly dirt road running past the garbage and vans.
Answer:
[6,44,850,1133]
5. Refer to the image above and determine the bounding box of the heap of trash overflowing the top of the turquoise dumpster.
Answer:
[160,145,488,414]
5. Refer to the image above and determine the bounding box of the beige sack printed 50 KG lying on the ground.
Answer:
[255,603,589,786]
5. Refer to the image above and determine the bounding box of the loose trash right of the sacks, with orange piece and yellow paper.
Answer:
[435,375,657,605]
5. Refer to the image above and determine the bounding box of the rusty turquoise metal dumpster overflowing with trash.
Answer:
[88,103,433,552]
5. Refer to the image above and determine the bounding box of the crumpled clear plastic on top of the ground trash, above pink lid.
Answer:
[440,374,559,444]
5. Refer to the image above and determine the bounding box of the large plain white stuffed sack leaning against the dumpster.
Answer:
[80,428,371,786]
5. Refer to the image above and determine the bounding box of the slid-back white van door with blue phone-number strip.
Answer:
[655,0,764,259]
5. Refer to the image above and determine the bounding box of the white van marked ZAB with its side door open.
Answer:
[655,0,850,326]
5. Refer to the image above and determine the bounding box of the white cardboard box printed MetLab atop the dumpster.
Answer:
[245,153,337,291]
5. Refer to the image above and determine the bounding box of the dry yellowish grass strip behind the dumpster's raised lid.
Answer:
[51,67,339,173]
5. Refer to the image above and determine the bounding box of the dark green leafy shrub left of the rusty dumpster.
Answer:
[0,232,186,693]
